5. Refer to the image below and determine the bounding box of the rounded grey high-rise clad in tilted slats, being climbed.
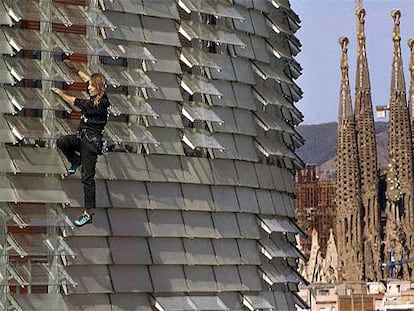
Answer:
[0,0,306,311]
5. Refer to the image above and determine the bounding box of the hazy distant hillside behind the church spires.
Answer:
[297,122,388,174]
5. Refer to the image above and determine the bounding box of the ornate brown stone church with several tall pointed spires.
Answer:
[336,8,414,281]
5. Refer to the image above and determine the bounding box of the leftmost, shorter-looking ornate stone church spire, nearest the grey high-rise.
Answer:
[336,37,363,281]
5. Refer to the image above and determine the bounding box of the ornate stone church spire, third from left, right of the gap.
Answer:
[385,10,414,278]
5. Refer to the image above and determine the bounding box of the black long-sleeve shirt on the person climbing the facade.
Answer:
[74,94,111,135]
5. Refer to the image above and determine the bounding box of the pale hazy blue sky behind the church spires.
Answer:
[290,0,414,124]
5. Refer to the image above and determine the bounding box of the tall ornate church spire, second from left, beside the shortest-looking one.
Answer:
[355,8,380,280]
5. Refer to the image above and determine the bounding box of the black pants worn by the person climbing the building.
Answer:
[57,135,98,209]
